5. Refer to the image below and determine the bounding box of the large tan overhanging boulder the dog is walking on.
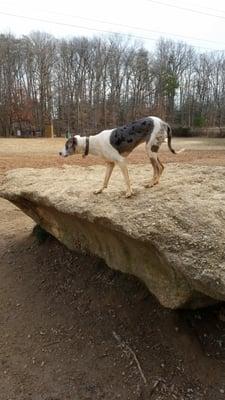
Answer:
[0,164,225,308]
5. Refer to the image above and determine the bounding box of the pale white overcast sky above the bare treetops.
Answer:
[0,0,225,51]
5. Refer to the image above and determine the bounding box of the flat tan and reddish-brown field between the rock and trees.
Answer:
[0,138,225,173]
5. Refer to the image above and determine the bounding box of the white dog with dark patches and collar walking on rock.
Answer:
[59,117,183,197]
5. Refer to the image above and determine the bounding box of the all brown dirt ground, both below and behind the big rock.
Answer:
[0,139,225,400]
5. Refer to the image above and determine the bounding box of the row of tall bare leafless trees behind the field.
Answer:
[0,32,225,135]
